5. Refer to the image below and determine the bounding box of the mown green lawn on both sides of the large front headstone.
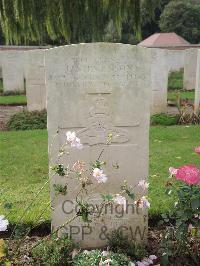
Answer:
[0,126,200,223]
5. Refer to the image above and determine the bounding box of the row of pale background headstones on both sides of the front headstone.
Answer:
[0,46,198,114]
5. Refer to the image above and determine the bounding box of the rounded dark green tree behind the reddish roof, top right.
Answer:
[160,0,200,43]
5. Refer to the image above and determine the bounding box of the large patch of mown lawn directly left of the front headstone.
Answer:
[0,130,49,223]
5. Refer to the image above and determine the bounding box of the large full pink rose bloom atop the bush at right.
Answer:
[176,165,200,185]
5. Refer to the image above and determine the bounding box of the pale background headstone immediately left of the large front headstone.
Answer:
[25,50,46,111]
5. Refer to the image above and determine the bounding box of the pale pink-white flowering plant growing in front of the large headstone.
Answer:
[51,131,150,235]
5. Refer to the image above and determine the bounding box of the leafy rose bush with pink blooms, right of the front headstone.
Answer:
[161,147,200,263]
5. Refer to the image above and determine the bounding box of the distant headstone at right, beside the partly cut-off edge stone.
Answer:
[183,48,198,90]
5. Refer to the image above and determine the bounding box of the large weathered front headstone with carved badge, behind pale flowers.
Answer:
[45,43,151,247]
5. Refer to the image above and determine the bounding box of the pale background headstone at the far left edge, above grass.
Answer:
[0,50,25,91]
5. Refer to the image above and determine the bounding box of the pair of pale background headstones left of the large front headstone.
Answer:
[0,49,46,111]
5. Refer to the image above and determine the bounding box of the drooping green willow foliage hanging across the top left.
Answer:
[0,0,159,44]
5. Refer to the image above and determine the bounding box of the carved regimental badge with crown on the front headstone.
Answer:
[78,93,129,145]
